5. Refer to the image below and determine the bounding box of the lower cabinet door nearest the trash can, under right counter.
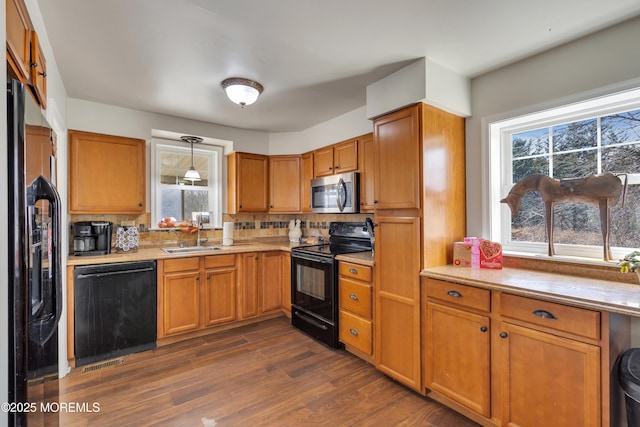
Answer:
[498,323,608,427]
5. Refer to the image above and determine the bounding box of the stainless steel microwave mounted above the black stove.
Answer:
[311,172,360,213]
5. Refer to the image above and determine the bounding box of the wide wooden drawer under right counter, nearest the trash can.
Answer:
[500,294,600,340]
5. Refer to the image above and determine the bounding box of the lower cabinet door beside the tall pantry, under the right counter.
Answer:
[425,302,491,417]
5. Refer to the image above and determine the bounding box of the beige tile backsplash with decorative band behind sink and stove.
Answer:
[69,213,373,246]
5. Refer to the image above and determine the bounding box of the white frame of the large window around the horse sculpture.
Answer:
[484,89,640,260]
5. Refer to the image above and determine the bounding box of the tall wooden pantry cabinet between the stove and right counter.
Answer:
[373,103,466,393]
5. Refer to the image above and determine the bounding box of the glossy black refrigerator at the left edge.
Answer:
[7,78,62,427]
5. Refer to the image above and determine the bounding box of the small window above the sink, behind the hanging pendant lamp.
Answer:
[151,138,223,228]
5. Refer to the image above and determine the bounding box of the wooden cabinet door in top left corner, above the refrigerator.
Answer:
[6,0,31,83]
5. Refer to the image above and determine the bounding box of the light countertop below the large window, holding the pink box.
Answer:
[420,265,640,317]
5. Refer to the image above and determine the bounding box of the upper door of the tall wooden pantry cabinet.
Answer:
[373,104,422,209]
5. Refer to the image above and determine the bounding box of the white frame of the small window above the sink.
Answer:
[150,138,225,229]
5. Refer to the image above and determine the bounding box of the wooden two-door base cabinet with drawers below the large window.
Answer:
[422,278,628,427]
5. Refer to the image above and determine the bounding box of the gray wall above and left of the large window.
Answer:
[466,14,640,237]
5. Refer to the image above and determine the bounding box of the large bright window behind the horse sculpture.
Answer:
[489,89,640,259]
